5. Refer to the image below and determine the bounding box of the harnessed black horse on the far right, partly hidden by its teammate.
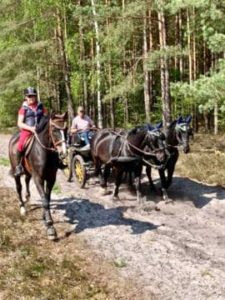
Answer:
[146,116,193,201]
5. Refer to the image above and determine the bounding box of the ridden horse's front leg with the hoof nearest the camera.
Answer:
[34,175,57,240]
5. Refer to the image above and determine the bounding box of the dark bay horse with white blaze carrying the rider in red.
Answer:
[9,114,66,240]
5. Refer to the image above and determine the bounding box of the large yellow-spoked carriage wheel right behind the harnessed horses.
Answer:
[73,155,87,188]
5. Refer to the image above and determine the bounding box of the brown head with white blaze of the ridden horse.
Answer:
[50,113,67,158]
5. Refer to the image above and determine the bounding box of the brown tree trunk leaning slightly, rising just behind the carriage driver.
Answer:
[56,9,74,126]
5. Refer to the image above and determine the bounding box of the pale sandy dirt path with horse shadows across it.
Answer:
[0,135,225,300]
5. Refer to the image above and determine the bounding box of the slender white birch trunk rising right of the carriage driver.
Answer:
[91,0,103,128]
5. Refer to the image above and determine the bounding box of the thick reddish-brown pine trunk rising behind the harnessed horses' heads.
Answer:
[158,11,171,129]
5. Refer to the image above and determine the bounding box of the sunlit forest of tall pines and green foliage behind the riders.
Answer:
[0,0,225,134]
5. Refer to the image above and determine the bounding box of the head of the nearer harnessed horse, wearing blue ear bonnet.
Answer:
[146,122,167,163]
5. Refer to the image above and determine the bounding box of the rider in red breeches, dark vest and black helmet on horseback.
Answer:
[14,87,47,176]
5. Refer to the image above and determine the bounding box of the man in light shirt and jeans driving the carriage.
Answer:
[70,106,96,146]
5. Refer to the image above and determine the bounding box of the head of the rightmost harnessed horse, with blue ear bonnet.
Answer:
[174,116,193,153]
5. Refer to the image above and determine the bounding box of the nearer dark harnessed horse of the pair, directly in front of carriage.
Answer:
[91,127,166,201]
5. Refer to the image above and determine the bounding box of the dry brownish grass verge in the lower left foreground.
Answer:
[0,188,134,300]
